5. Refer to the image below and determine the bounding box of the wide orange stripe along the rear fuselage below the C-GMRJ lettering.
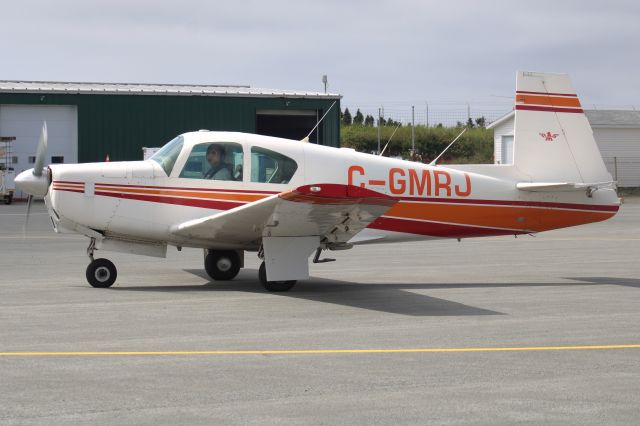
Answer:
[385,202,615,232]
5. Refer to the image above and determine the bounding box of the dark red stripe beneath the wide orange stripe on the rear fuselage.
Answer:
[368,217,528,238]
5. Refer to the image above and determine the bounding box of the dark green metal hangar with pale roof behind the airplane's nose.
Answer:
[0,81,341,178]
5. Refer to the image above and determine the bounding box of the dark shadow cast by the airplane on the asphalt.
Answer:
[113,269,640,316]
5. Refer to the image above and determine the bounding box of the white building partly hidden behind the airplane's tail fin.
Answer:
[487,110,640,187]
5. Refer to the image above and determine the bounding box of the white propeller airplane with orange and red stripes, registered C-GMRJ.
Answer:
[15,72,621,291]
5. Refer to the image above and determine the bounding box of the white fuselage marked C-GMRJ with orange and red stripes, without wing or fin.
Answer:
[45,132,619,249]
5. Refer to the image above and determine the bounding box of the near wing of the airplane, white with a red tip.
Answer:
[171,184,397,248]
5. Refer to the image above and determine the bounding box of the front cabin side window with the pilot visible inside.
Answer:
[180,142,242,181]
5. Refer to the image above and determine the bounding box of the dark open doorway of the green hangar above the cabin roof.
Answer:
[256,109,322,144]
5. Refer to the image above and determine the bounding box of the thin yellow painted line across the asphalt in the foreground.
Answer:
[0,344,640,357]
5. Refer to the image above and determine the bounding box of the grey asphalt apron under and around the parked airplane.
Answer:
[0,198,640,425]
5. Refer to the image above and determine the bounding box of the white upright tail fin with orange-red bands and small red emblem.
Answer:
[513,72,612,184]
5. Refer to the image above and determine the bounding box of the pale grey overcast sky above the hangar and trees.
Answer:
[0,0,640,116]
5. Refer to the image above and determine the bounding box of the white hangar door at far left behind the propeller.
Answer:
[0,105,78,196]
